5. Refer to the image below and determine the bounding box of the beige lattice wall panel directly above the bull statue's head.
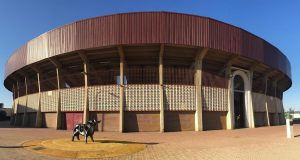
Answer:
[88,85,120,111]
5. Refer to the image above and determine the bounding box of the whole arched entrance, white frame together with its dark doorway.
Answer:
[227,70,254,129]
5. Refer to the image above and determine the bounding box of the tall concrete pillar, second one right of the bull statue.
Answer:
[158,44,165,132]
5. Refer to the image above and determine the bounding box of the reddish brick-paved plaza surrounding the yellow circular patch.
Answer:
[0,122,300,160]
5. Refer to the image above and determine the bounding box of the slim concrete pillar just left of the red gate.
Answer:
[56,67,62,129]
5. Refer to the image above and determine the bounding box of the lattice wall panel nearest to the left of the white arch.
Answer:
[202,86,228,111]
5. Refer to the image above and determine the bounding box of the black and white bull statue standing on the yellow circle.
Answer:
[72,120,101,143]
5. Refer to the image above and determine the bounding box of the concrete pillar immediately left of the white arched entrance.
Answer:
[225,64,234,129]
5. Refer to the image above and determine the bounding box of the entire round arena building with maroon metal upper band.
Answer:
[4,12,292,132]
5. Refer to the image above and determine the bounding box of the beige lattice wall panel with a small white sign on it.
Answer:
[41,90,58,112]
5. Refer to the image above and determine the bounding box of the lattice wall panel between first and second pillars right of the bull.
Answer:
[125,84,160,111]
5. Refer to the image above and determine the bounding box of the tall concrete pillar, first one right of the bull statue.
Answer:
[118,46,124,132]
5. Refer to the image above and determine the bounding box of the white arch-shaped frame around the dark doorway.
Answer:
[228,70,255,129]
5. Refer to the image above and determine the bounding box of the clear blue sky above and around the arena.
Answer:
[0,0,300,110]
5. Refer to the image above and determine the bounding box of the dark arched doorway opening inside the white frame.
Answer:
[233,75,246,128]
